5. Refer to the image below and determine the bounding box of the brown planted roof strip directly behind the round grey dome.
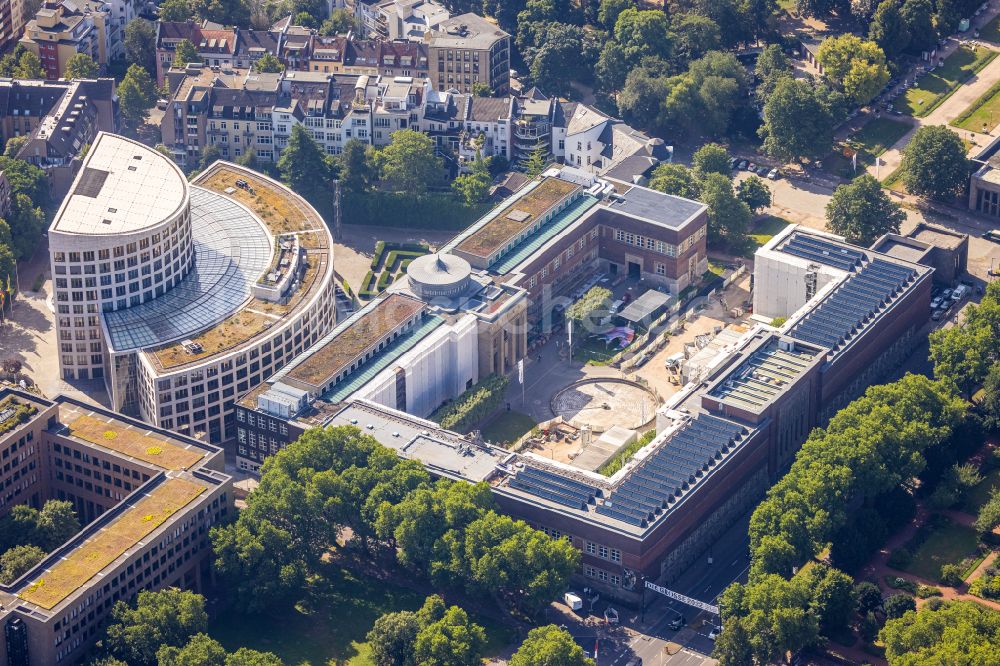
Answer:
[457,178,580,259]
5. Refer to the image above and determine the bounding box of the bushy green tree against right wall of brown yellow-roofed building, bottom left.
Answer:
[105,588,208,666]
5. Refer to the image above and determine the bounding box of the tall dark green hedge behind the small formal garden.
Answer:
[343,192,489,230]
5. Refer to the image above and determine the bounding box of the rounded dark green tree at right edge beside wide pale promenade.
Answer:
[900,125,969,199]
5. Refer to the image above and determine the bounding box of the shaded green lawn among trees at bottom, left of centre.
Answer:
[208,569,513,666]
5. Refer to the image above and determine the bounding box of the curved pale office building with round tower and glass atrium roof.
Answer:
[49,131,336,442]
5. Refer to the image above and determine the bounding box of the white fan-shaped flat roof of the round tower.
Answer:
[52,132,187,236]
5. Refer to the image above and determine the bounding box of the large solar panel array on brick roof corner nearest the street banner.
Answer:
[596,414,748,527]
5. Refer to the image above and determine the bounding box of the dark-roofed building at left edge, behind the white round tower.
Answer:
[0,79,118,198]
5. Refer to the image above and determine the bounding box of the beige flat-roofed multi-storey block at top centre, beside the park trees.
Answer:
[424,13,510,95]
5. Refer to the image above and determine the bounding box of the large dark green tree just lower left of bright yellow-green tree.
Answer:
[759,77,835,160]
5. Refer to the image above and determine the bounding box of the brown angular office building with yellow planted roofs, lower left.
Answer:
[0,389,234,666]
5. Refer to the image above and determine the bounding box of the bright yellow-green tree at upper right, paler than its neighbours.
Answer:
[816,33,889,104]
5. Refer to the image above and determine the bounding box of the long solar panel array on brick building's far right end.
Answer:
[790,259,917,349]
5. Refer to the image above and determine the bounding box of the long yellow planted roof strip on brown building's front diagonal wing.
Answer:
[18,479,205,609]
